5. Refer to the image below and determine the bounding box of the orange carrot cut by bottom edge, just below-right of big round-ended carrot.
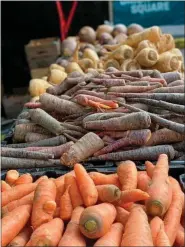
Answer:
[94,223,123,246]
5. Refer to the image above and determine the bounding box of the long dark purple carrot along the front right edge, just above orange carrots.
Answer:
[89,145,175,161]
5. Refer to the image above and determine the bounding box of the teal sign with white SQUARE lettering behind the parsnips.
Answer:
[109,1,185,37]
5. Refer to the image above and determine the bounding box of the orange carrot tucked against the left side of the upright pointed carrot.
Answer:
[65,174,83,208]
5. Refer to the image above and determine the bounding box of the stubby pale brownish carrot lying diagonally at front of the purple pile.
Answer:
[61,132,104,166]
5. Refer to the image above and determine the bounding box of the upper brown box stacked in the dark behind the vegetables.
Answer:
[25,38,61,70]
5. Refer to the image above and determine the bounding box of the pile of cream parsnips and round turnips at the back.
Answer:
[29,24,184,100]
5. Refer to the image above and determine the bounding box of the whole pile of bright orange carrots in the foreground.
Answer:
[1,154,185,247]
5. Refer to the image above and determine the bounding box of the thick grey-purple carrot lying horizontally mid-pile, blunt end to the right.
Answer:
[83,112,151,130]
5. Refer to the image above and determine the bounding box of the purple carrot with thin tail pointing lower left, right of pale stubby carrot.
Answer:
[94,130,151,156]
